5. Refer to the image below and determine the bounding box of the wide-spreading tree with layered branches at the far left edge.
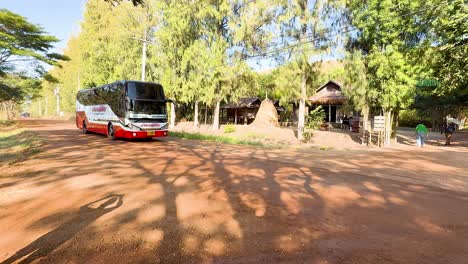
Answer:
[0,9,68,118]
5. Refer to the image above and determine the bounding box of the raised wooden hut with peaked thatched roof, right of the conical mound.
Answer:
[308,80,346,123]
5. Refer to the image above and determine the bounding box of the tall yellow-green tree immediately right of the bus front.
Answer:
[150,1,203,127]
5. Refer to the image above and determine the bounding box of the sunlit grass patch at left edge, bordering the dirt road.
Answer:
[0,123,42,166]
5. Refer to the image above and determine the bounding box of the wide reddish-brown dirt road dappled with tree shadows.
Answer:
[0,121,468,264]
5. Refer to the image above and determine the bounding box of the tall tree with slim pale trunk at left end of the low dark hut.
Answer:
[204,0,277,130]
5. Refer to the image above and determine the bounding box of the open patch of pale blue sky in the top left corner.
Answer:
[0,0,85,51]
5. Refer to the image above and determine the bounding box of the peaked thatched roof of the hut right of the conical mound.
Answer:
[308,80,346,104]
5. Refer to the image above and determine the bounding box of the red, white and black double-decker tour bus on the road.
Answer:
[76,81,169,139]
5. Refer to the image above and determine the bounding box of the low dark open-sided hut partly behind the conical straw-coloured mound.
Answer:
[221,97,284,125]
